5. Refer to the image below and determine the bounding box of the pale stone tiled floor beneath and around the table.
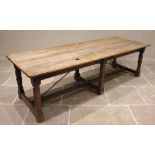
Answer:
[0,58,155,125]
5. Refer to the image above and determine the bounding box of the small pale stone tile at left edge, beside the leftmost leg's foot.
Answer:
[0,86,17,105]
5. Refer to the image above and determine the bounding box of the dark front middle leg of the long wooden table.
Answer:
[98,60,105,95]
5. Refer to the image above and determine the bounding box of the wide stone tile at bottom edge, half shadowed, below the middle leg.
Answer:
[69,106,135,125]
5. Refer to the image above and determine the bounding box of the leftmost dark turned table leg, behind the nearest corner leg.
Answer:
[14,65,25,99]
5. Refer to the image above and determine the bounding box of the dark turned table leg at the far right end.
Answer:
[135,48,145,77]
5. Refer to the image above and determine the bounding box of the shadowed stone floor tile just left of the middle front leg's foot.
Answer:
[62,87,107,105]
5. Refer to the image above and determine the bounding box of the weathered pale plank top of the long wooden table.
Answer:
[7,37,149,78]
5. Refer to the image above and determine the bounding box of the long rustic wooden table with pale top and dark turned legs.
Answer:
[7,37,150,122]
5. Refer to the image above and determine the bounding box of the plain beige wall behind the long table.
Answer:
[0,30,155,59]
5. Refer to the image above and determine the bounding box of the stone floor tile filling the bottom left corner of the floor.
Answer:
[0,105,27,125]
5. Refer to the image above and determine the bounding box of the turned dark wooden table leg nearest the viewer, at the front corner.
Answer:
[31,79,44,122]
